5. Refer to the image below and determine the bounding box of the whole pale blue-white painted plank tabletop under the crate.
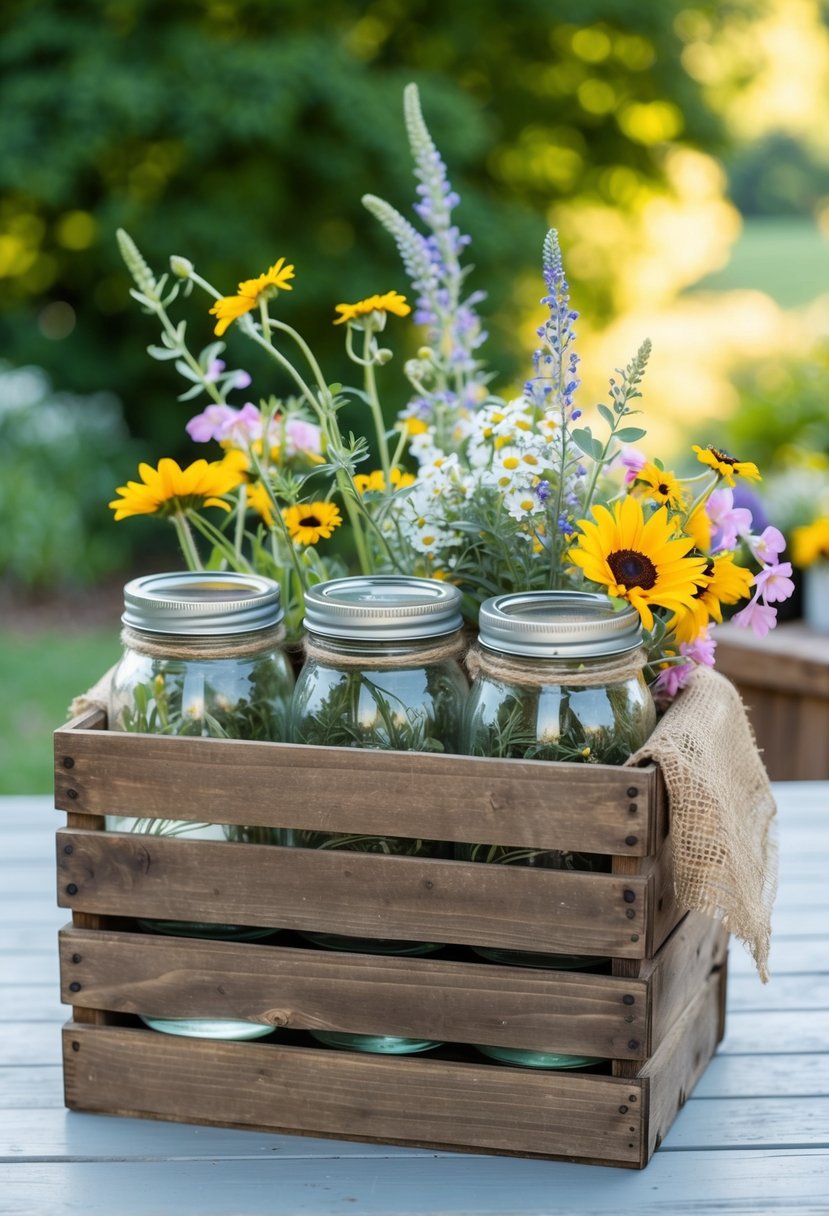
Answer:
[0,782,829,1216]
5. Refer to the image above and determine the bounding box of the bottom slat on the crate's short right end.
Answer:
[638,958,723,1164]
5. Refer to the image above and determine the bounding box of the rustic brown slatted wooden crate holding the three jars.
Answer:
[55,713,727,1167]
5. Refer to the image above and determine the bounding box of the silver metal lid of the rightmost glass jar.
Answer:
[478,591,642,659]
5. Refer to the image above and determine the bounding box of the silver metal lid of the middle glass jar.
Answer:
[304,574,463,642]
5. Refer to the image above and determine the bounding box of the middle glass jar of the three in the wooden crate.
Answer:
[286,575,468,1052]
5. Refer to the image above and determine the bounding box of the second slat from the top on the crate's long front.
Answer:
[57,829,650,958]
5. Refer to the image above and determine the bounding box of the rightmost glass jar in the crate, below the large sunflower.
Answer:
[456,591,656,1068]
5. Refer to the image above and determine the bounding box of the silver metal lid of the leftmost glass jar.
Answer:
[122,570,284,637]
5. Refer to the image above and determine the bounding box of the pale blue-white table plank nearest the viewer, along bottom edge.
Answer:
[0,1149,827,1216]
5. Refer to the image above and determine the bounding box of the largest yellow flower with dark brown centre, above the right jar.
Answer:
[568,497,706,629]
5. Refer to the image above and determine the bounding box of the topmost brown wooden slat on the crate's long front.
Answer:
[55,730,661,856]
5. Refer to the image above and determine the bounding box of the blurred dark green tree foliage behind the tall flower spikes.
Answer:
[0,0,717,456]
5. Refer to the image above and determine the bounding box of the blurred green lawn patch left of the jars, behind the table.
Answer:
[0,627,120,794]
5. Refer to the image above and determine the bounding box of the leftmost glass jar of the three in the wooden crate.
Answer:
[107,572,293,1038]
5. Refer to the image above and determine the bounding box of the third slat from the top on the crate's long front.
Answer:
[61,930,647,1059]
